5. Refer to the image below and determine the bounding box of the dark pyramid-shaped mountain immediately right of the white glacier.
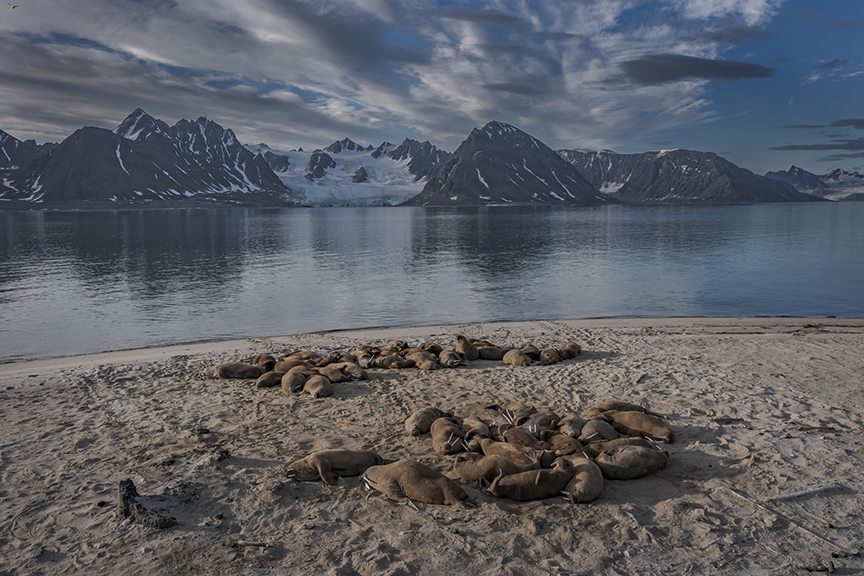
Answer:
[406,121,617,206]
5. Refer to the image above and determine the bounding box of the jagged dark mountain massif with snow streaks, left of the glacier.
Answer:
[0,109,296,207]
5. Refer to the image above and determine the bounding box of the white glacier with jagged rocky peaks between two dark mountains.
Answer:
[247,138,449,206]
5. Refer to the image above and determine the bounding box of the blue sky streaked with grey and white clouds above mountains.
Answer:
[0,0,864,174]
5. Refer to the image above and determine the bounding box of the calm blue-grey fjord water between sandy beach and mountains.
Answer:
[0,203,864,361]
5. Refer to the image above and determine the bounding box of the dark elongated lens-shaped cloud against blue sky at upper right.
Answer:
[621,54,773,85]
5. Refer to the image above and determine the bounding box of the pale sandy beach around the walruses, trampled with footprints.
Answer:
[0,318,864,576]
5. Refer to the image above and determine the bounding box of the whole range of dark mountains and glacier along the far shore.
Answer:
[0,109,864,209]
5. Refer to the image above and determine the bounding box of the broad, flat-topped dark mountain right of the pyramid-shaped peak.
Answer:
[558,149,818,204]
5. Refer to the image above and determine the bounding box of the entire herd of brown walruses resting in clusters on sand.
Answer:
[201,334,675,507]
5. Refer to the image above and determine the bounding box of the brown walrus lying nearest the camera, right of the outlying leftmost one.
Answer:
[363,460,477,508]
